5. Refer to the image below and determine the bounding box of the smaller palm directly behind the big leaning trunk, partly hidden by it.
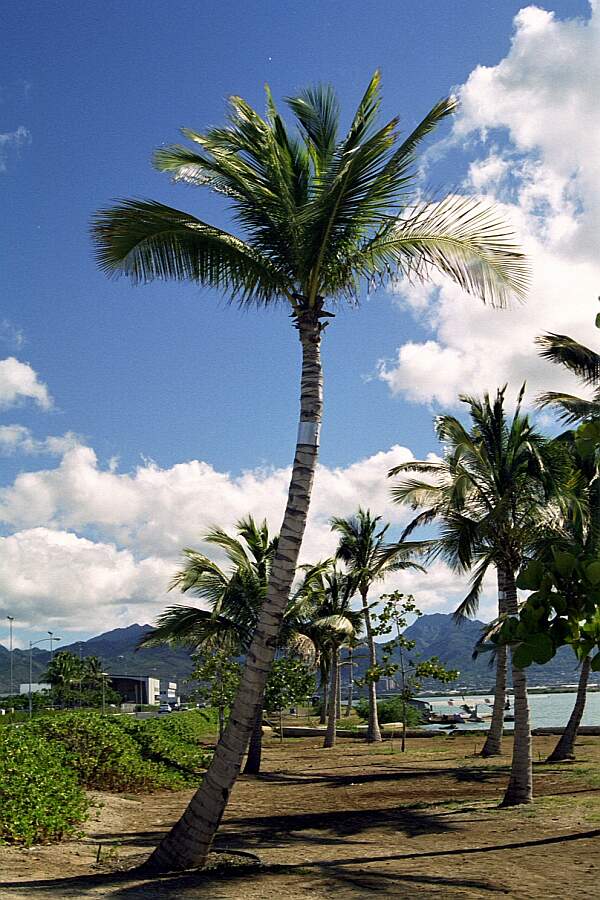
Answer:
[139,516,314,775]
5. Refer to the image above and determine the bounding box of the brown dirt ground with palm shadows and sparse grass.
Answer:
[0,734,600,900]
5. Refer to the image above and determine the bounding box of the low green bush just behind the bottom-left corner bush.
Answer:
[32,712,186,792]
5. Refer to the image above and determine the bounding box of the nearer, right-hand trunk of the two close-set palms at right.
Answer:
[502,569,533,806]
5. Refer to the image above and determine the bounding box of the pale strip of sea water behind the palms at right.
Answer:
[421,691,600,730]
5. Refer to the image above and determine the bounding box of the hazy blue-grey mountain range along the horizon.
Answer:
[0,613,600,694]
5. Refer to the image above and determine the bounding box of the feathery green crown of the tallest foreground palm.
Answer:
[92,73,528,312]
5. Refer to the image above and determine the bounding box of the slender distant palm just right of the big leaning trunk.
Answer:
[331,508,422,741]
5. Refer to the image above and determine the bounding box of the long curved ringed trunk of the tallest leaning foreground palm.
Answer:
[146,307,323,872]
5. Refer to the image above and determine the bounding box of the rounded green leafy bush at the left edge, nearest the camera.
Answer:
[0,727,88,847]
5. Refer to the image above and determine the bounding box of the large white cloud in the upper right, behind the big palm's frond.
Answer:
[379,5,600,406]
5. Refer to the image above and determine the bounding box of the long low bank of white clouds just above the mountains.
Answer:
[0,436,490,631]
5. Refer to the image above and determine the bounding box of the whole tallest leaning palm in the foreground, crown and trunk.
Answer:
[93,73,528,871]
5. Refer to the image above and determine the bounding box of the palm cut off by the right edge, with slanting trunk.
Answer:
[536,334,600,762]
